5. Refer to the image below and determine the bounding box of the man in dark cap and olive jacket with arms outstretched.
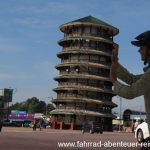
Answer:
[110,31,150,137]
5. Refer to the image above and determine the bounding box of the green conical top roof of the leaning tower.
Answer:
[60,16,119,35]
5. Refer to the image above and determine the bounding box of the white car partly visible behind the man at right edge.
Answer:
[135,122,150,143]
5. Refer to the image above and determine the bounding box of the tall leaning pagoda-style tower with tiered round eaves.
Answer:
[51,16,119,131]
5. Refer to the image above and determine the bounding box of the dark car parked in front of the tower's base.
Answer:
[82,121,103,134]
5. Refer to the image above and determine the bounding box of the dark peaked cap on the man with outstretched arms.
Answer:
[131,31,150,47]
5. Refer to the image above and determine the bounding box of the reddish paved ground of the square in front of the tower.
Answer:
[0,127,145,150]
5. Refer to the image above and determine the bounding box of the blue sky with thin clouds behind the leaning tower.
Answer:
[0,0,150,114]
